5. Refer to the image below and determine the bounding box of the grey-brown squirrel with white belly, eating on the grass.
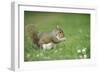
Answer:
[25,25,66,49]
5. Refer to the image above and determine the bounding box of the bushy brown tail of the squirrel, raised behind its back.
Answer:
[25,24,39,46]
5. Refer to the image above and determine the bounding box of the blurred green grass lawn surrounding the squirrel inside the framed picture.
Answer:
[24,11,90,61]
